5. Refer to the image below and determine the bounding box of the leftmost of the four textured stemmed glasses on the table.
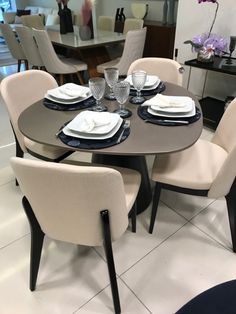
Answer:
[89,77,107,111]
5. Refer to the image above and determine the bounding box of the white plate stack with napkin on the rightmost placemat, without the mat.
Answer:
[142,94,196,118]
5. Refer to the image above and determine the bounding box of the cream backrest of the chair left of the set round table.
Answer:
[0,70,58,152]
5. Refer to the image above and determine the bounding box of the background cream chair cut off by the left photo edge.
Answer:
[0,23,28,72]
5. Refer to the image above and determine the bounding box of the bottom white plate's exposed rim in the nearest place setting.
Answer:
[62,117,123,140]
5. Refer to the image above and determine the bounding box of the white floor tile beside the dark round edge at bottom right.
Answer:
[121,223,236,314]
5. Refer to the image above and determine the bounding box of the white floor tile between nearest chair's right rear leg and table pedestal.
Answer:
[96,203,186,275]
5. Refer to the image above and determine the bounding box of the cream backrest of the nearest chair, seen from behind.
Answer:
[11,157,128,246]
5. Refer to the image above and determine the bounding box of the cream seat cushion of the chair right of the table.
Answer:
[152,139,228,190]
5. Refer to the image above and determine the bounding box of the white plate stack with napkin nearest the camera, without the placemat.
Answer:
[63,110,123,140]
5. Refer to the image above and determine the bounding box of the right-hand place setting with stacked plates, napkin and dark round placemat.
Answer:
[138,94,201,126]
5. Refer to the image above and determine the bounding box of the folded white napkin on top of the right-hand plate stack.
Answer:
[142,94,193,109]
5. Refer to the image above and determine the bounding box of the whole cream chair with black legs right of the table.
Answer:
[149,99,236,252]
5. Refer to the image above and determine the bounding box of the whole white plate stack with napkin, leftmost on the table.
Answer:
[45,83,91,105]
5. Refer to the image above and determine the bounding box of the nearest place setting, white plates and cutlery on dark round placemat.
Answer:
[56,110,130,149]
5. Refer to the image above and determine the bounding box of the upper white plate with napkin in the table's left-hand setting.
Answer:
[47,83,90,101]
